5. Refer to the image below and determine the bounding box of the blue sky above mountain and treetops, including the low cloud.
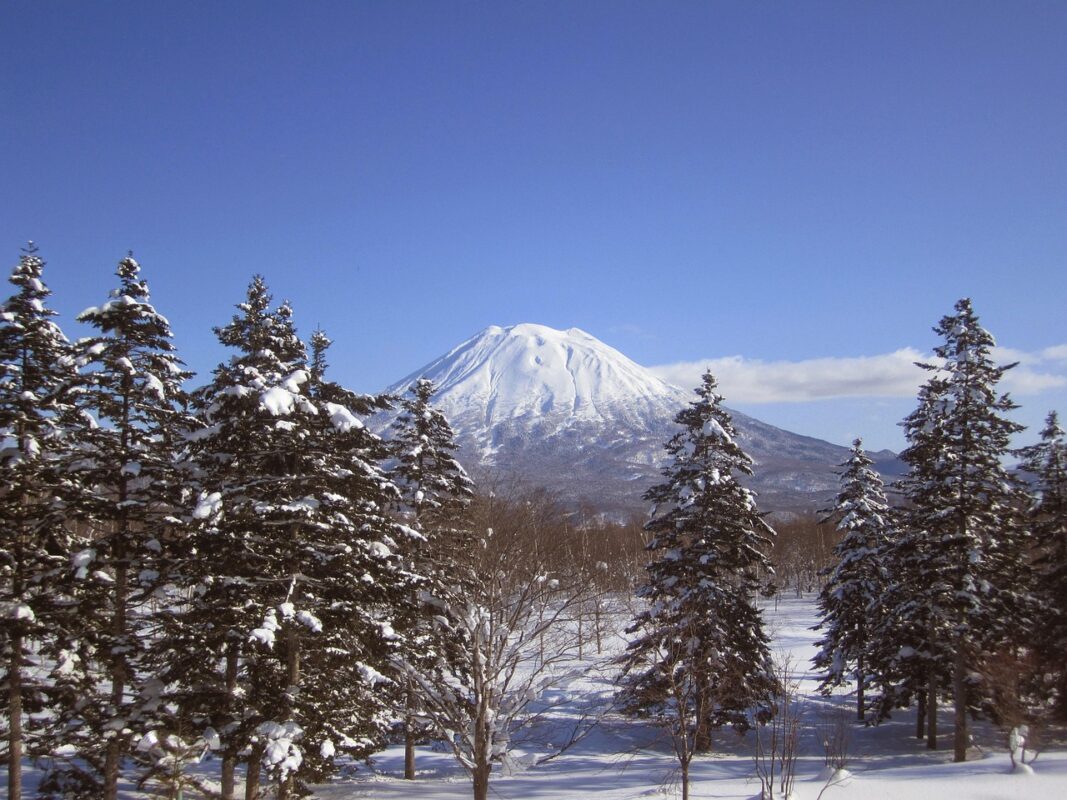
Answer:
[0,0,1067,448]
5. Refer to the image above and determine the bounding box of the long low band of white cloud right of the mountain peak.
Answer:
[651,345,1067,403]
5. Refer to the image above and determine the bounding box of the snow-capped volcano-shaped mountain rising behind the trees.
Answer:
[387,323,896,513]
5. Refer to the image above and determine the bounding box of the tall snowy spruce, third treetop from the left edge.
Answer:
[154,277,292,800]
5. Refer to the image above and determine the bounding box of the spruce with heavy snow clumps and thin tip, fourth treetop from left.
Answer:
[302,332,421,793]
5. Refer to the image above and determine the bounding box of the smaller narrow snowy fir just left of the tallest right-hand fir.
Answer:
[813,438,890,720]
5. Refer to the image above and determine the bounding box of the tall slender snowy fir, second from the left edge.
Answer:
[36,257,196,800]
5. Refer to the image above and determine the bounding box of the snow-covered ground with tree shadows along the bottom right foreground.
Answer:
[316,597,1067,800]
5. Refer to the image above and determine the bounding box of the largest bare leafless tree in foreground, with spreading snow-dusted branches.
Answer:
[400,498,595,800]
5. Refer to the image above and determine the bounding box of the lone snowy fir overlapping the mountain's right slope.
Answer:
[620,372,777,750]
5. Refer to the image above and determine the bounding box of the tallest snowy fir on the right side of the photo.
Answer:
[891,299,1030,761]
